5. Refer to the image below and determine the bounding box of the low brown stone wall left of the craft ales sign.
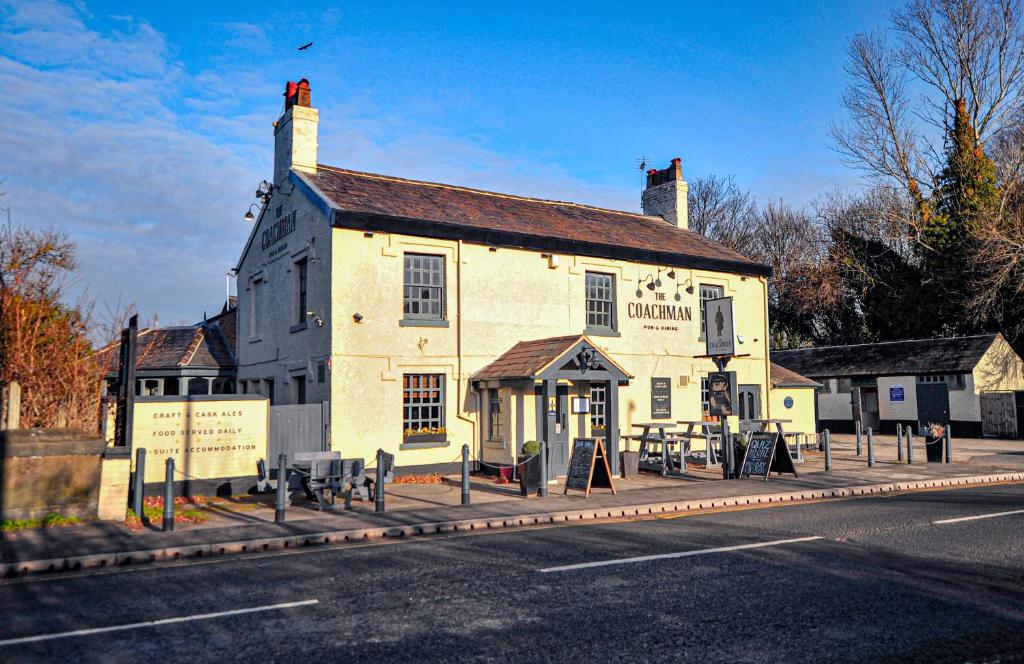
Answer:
[0,429,106,518]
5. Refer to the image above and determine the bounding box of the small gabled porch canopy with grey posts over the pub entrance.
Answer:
[472,334,632,471]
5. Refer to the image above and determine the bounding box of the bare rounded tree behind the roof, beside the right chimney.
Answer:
[687,175,758,255]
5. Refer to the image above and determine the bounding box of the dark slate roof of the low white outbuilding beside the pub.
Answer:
[771,334,996,378]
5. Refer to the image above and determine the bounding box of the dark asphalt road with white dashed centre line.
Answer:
[0,485,1024,663]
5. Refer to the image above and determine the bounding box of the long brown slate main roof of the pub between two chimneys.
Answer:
[296,165,771,275]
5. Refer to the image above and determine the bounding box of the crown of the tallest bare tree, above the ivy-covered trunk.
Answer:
[833,0,1024,230]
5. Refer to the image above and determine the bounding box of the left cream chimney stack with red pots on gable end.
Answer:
[273,79,319,184]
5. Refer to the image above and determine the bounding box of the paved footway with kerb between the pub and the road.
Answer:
[0,453,1020,570]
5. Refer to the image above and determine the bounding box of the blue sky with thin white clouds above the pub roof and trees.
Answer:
[0,0,894,324]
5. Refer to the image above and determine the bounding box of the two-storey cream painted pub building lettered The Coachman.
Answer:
[236,82,784,473]
